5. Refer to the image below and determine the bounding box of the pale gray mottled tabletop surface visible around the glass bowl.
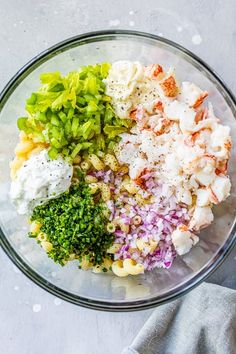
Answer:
[0,0,236,354]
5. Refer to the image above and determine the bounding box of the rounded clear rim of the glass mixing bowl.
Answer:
[0,29,236,312]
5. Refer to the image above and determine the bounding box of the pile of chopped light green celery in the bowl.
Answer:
[17,63,132,160]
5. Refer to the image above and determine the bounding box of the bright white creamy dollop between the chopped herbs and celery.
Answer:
[10,150,73,214]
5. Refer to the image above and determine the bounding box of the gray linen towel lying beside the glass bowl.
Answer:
[122,283,236,354]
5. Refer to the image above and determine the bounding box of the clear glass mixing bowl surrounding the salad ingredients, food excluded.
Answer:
[0,30,236,311]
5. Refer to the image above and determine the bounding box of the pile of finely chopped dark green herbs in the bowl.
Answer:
[29,180,114,265]
